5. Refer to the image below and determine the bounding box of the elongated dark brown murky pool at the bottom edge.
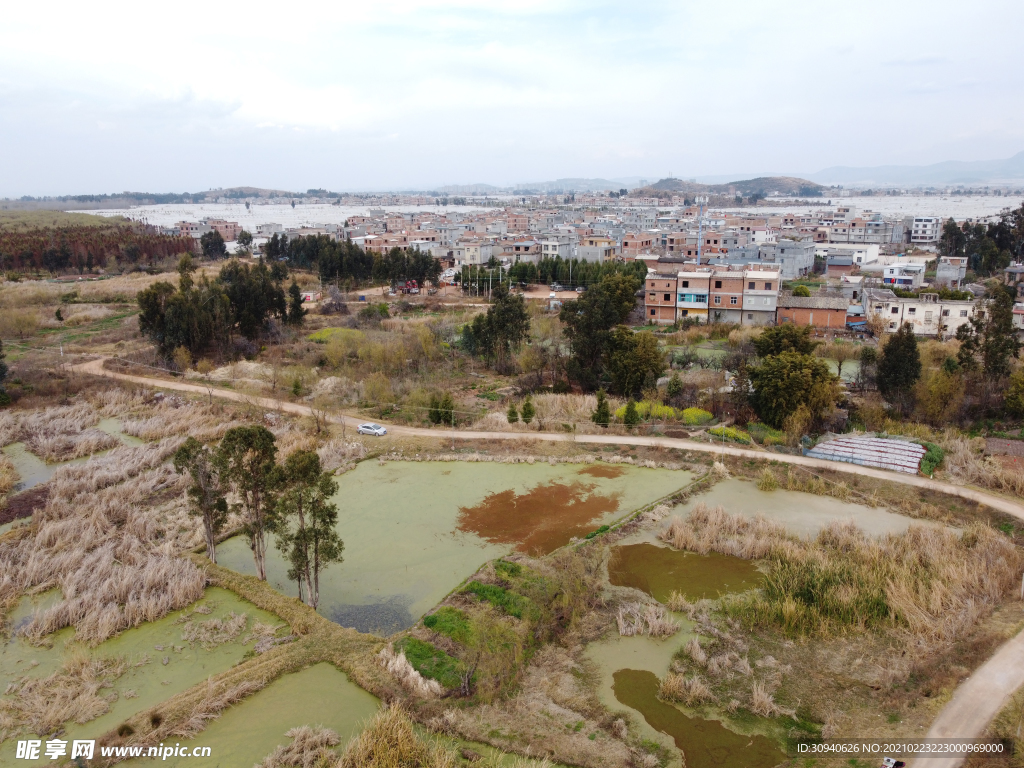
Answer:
[613,670,786,768]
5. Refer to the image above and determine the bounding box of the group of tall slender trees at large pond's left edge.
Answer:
[173,426,345,608]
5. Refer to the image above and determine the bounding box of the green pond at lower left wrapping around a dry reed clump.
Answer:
[0,587,286,765]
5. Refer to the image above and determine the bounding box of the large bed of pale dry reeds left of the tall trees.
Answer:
[0,440,206,645]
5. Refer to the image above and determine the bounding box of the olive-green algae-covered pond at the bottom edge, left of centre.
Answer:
[123,663,380,768]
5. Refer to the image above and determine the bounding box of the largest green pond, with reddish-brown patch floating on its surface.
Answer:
[217,462,691,635]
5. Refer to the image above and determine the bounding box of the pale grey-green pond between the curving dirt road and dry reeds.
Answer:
[674,479,930,536]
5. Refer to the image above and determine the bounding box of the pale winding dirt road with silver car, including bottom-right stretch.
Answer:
[72,357,1024,757]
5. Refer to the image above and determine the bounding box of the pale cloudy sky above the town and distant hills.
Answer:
[0,0,1024,197]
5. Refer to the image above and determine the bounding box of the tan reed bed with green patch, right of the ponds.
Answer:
[659,504,1024,647]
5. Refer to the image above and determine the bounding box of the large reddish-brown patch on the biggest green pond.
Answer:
[458,481,620,555]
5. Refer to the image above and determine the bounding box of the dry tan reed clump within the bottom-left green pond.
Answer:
[0,651,129,741]
